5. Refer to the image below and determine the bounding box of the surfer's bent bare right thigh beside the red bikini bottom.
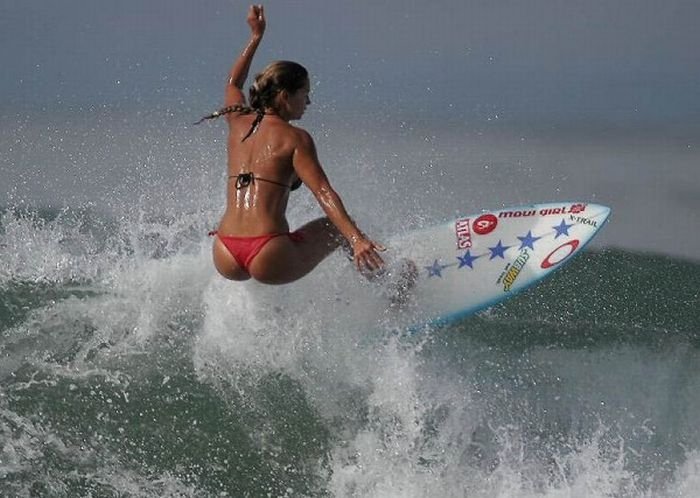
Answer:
[249,218,340,284]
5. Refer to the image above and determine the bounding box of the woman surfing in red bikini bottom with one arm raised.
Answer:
[200,5,384,284]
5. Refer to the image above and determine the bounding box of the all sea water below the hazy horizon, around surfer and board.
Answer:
[0,109,700,497]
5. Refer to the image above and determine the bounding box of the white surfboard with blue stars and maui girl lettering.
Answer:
[390,202,610,326]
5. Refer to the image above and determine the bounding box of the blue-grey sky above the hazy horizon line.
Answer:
[0,0,700,124]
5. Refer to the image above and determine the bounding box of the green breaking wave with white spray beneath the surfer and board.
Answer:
[0,209,700,497]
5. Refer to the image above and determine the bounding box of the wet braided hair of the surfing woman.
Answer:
[194,61,309,142]
